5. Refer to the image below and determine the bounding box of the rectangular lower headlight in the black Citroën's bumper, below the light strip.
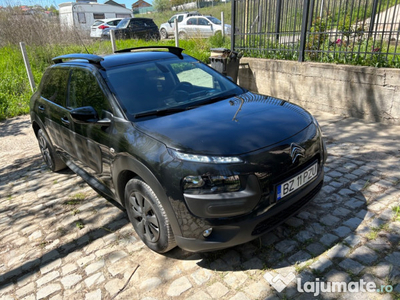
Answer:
[182,175,241,194]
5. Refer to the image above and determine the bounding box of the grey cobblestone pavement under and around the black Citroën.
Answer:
[0,114,400,300]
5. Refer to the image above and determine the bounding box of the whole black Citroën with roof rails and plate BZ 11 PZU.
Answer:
[30,47,327,253]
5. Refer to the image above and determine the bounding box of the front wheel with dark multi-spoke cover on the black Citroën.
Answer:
[125,178,176,253]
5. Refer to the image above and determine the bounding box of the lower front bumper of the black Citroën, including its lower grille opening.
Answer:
[175,171,324,252]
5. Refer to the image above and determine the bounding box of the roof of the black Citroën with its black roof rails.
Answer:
[53,46,194,70]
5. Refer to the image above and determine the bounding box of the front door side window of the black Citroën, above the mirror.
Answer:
[68,69,111,116]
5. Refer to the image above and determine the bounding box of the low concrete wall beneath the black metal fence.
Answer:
[238,58,400,124]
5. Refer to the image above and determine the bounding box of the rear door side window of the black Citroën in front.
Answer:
[41,68,69,106]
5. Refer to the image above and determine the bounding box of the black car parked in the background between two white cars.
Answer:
[101,18,160,40]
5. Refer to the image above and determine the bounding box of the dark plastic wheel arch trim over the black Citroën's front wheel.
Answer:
[112,155,181,235]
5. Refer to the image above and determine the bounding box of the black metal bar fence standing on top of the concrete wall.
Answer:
[231,0,400,67]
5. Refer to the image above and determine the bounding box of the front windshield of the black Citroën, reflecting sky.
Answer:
[103,58,245,119]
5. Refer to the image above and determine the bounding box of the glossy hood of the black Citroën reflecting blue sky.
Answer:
[135,92,313,155]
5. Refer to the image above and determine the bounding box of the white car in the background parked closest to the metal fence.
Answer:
[178,16,231,39]
